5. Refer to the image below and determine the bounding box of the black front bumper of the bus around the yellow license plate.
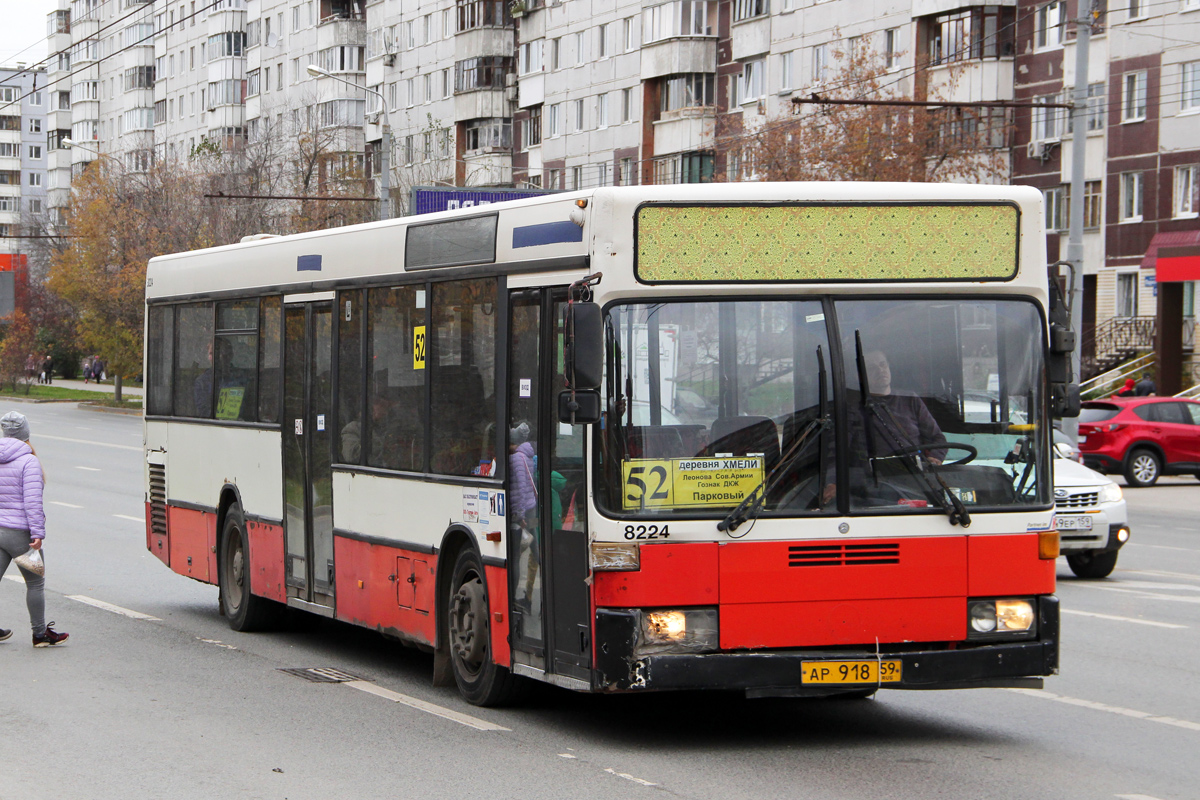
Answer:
[595,595,1058,697]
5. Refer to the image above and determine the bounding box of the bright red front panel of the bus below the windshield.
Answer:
[594,533,1055,649]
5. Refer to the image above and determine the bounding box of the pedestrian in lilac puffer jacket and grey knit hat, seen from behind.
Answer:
[0,411,67,648]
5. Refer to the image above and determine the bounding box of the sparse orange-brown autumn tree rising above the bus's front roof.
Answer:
[720,47,1010,184]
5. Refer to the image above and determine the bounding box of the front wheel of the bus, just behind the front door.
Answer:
[444,547,522,706]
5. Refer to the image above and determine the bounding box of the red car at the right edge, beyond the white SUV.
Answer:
[1079,397,1200,486]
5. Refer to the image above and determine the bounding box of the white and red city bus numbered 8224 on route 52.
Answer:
[145,182,1070,704]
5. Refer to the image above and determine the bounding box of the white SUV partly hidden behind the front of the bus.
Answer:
[1054,453,1129,578]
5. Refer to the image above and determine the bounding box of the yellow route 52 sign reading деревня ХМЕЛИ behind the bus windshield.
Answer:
[622,456,763,510]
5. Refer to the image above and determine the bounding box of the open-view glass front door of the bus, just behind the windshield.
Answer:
[506,289,592,681]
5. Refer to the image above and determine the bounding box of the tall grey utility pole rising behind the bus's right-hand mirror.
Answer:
[1062,0,1094,441]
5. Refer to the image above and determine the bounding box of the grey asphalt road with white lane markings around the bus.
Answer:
[0,404,1200,800]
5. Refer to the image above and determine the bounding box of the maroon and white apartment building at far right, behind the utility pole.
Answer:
[1013,0,1200,376]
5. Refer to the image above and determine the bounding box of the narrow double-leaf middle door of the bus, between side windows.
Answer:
[283,302,334,616]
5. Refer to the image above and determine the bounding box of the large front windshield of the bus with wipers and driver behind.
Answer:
[596,297,1050,517]
